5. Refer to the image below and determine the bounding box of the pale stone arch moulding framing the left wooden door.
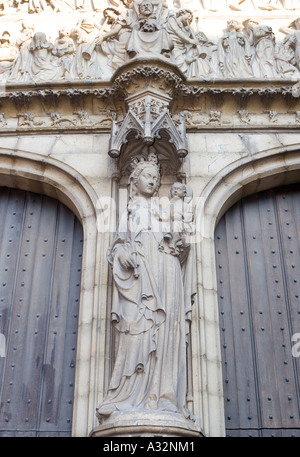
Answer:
[0,148,106,436]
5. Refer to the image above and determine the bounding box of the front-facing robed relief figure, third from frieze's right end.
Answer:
[218,20,254,78]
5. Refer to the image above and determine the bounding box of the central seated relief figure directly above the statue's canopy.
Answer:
[127,0,173,59]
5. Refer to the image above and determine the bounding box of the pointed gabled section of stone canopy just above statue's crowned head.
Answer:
[109,90,188,158]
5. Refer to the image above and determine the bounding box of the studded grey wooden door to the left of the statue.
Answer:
[0,188,82,436]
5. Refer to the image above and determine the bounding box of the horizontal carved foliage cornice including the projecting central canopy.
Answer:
[0,74,300,134]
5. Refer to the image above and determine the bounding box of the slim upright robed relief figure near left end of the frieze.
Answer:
[8,21,34,81]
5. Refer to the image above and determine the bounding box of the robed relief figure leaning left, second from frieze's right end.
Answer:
[243,19,278,78]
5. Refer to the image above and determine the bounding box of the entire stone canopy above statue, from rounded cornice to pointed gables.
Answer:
[108,60,188,181]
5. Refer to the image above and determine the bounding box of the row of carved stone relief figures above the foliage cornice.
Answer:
[0,0,300,82]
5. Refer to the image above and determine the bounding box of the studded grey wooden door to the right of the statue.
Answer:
[215,185,300,436]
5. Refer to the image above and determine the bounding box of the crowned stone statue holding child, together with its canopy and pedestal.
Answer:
[91,58,201,437]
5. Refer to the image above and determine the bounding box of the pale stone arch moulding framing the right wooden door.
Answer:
[193,145,300,436]
